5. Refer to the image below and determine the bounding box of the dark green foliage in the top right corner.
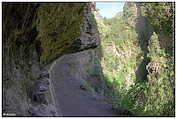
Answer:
[142,2,174,36]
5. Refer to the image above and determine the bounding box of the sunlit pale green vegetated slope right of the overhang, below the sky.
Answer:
[95,14,143,114]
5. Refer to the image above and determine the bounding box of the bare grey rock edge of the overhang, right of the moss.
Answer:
[72,5,100,51]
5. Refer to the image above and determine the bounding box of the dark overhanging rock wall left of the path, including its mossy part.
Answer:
[3,3,99,116]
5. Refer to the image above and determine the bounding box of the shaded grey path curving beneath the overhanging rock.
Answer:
[50,56,118,116]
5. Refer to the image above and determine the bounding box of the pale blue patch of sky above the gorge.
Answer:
[96,2,125,18]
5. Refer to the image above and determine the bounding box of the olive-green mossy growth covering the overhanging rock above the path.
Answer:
[37,3,85,63]
